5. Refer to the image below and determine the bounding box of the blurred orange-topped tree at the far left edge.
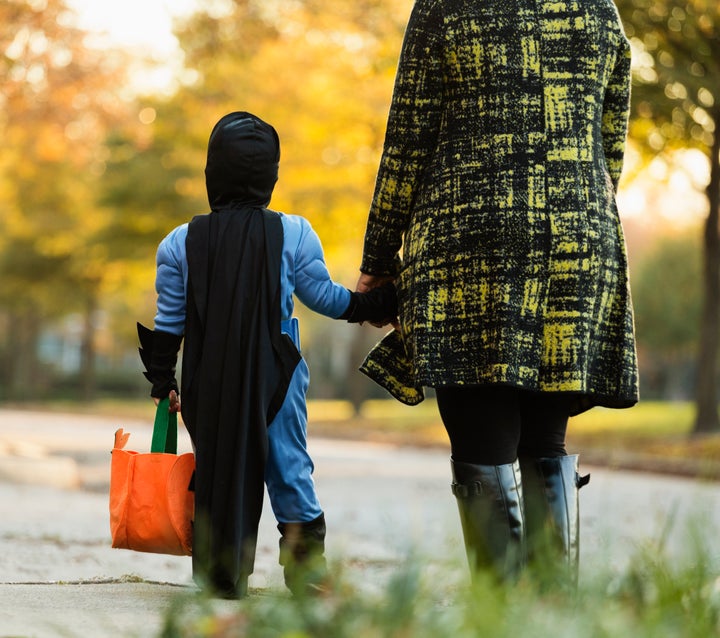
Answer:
[0,0,128,397]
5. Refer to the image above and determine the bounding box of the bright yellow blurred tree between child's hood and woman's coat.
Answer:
[158,0,411,276]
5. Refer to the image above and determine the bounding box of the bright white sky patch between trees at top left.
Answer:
[66,0,198,91]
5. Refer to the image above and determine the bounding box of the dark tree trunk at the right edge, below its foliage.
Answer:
[692,124,720,435]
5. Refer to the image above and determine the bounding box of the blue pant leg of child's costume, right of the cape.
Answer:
[265,359,322,523]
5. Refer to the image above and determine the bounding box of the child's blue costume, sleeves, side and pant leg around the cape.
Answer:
[155,213,351,523]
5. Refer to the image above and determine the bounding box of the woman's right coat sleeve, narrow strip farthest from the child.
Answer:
[602,36,630,190]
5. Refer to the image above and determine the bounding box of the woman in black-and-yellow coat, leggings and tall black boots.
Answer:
[358,0,637,588]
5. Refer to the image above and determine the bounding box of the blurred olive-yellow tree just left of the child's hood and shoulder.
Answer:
[95,102,207,356]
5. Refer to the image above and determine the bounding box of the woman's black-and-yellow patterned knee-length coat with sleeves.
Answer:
[361,0,637,412]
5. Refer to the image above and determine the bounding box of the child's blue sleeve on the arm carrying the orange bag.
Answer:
[155,224,187,335]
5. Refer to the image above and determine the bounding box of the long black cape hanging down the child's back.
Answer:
[181,205,300,588]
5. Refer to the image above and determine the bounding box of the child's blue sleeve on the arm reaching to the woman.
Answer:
[295,221,350,319]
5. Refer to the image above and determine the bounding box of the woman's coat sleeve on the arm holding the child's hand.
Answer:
[360,0,444,275]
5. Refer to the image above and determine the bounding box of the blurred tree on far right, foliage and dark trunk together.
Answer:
[616,0,720,434]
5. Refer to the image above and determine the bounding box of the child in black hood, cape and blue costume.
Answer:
[138,112,397,598]
